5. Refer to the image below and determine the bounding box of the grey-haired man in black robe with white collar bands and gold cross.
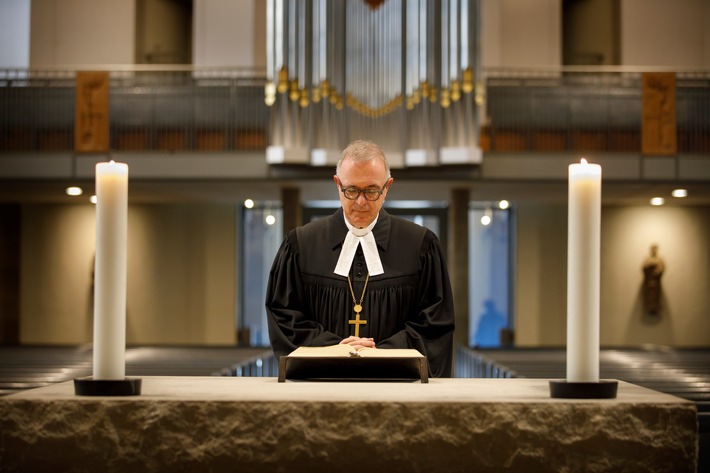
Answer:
[266,141,454,377]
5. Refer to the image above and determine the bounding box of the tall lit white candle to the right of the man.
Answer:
[567,160,602,382]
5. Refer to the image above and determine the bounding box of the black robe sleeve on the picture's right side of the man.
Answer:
[377,231,454,378]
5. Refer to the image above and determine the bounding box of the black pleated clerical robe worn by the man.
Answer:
[266,209,454,377]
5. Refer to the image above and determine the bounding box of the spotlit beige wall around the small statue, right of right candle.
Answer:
[601,205,710,346]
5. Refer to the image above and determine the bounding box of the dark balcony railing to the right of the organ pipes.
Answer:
[480,68,710,153]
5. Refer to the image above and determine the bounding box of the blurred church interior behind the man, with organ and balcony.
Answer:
[0,0,710,472]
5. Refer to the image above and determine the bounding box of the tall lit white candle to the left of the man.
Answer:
[94,161,128,380]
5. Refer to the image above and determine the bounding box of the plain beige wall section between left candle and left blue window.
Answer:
[126,204,236,344]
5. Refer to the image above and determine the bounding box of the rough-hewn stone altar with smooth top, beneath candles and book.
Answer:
[0,377,698,473]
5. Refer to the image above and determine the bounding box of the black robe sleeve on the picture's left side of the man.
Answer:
[266,230,342,358]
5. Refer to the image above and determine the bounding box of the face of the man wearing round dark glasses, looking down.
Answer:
[333,159,393,228]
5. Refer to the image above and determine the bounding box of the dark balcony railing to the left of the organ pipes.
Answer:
[0,70,269,152]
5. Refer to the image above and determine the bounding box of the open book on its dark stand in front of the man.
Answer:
[279,344,429,383]
